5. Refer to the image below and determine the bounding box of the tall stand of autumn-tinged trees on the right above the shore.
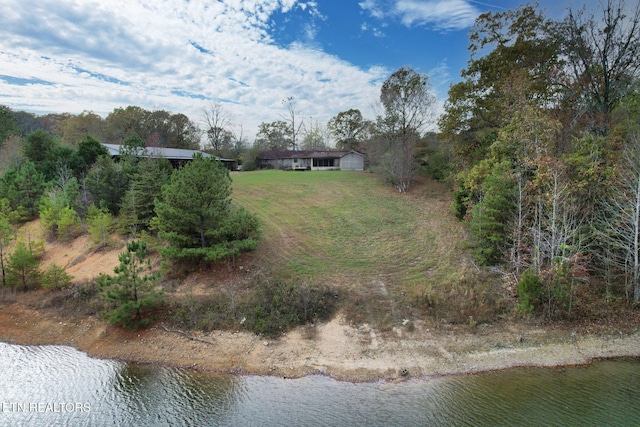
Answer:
[439,0,640,318]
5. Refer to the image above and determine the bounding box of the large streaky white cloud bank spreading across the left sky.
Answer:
[0,0,387,144]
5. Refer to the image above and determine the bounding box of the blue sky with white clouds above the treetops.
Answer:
[0,0,596,142]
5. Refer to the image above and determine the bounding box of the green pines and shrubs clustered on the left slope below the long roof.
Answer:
[0,123,260,327]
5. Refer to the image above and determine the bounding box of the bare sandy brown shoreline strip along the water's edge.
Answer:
[0,304,640,381]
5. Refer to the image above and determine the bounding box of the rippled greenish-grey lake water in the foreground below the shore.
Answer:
[0,343,640,426]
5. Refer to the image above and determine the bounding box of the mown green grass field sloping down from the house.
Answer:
[232,170,478,324]
